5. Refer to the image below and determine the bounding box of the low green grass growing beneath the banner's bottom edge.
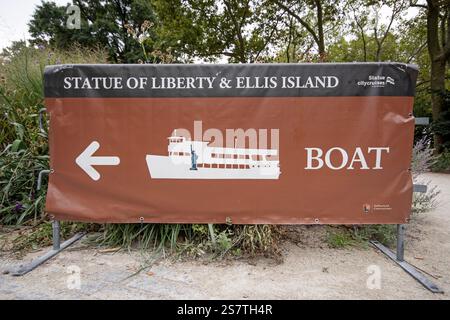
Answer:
[96,224,281,258]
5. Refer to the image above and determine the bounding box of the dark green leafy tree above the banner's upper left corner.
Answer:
[29,0,160,62]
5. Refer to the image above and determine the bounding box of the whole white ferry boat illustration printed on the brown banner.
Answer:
[146,136,280,179]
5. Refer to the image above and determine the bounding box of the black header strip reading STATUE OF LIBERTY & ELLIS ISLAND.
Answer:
[44,62,418,98]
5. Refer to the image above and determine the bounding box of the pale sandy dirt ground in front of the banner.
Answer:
[0,174,450,299]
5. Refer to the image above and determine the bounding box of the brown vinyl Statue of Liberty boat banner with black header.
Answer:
[45,63,417,224]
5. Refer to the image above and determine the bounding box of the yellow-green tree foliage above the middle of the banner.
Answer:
[154,0,283,63]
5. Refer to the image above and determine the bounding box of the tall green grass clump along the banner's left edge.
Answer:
[0,43,106,225]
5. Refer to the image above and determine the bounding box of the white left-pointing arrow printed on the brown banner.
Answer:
[75,141,120,181]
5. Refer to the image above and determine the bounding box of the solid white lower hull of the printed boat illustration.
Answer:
[146,155,280,179]
